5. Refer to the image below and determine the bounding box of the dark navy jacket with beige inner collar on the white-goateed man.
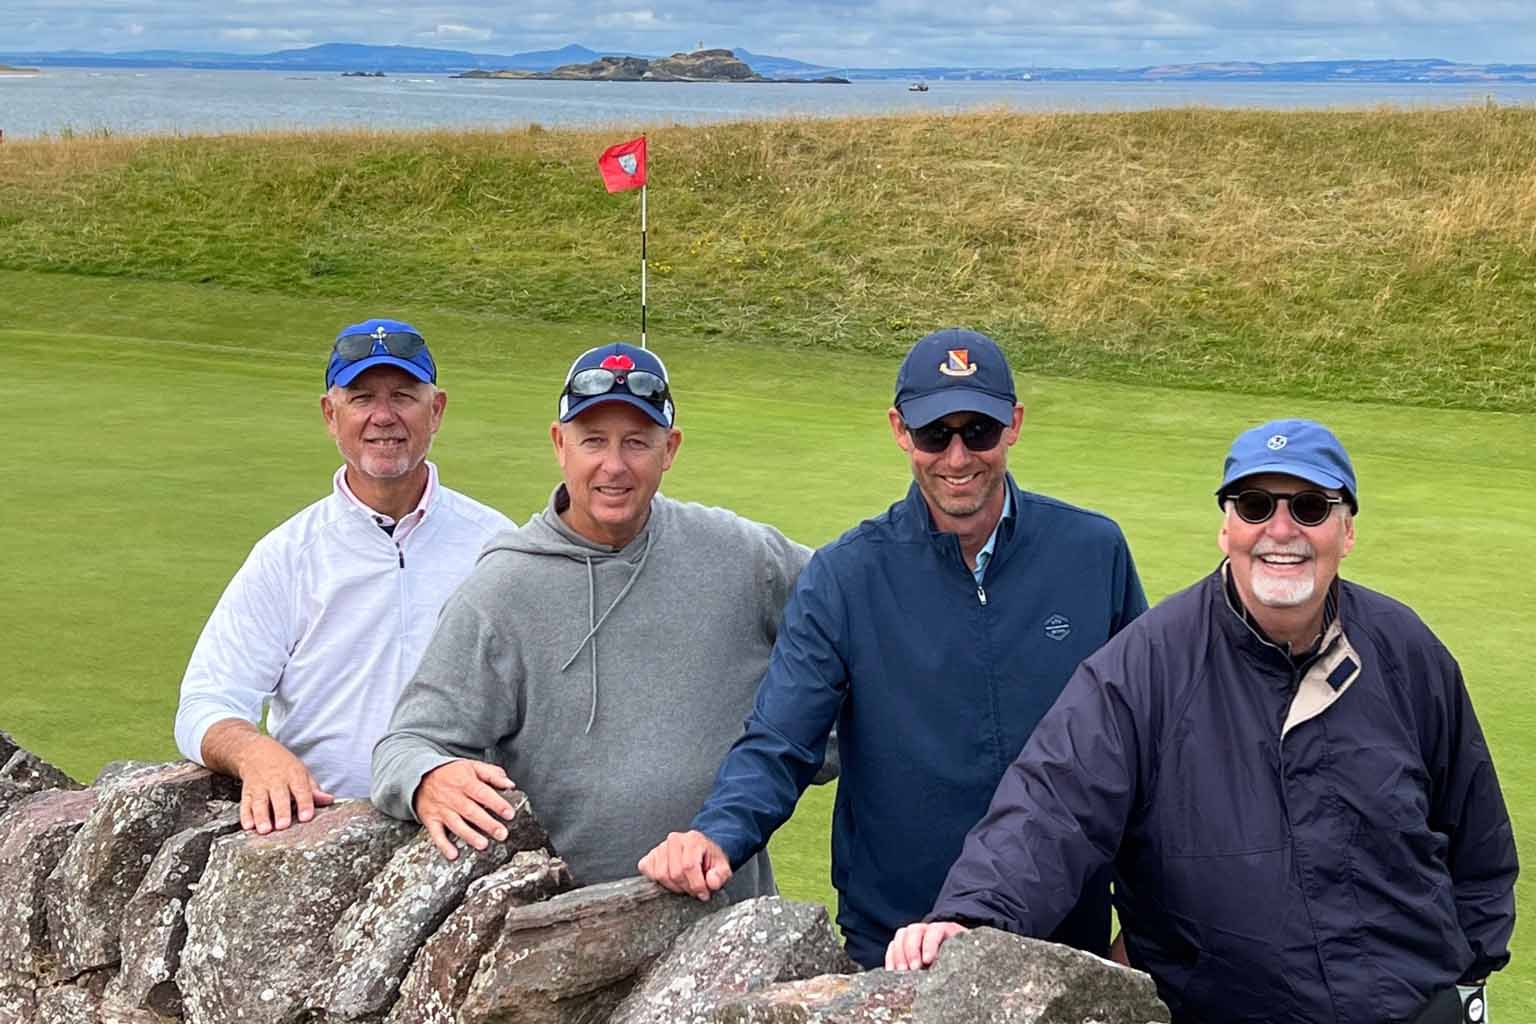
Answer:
[931,570,1518,1024]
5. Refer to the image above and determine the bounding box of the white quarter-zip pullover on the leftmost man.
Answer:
[175,462,511,798]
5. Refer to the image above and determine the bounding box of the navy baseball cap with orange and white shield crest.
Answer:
[895,327,1018,427]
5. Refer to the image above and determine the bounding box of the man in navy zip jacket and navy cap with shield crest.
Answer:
[629,330,1146,966]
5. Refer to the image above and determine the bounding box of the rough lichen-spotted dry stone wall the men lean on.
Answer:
[0,732,1169,1024]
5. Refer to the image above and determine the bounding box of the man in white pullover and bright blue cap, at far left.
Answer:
[175,319,511,834]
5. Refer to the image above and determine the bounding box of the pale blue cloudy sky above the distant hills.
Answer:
[0,0,1536,68]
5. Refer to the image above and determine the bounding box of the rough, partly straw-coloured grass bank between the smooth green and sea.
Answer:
[9,106,1536,411]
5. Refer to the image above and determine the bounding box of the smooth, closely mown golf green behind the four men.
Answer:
[0,272,1536,1021]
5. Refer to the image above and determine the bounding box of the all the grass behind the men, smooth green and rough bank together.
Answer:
[0,111,1536,1021]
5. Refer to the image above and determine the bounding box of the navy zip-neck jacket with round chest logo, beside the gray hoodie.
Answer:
[693,479,1146,966]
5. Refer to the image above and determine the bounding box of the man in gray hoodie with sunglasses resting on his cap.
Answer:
[373,344,809,898]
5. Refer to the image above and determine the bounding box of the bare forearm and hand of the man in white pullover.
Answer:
[203,718,335,835]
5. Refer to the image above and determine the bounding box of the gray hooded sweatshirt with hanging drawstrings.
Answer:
[373,487,809,900]
